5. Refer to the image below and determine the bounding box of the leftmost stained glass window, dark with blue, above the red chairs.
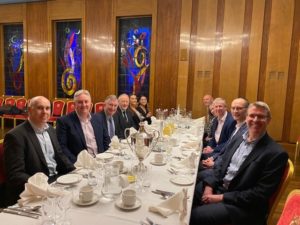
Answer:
[3,24,25,96]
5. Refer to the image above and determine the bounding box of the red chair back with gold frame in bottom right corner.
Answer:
[277,189,300,225]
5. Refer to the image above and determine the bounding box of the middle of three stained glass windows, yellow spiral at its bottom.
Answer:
[55,21,82,98]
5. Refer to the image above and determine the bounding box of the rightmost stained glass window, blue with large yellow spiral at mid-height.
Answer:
[118,17,152,97]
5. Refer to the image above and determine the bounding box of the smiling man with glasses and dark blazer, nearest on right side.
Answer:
[190,102,288,225]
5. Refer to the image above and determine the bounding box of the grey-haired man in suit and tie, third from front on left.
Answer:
[99,95,119,138]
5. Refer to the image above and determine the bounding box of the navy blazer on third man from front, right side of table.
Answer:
[207,112,236,154]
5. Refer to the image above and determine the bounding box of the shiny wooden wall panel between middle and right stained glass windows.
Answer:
[86,0,116,102]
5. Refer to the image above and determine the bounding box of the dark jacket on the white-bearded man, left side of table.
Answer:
[113,107,134,139]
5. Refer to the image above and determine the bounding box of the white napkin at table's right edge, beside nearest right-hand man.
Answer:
[149,188,188,221]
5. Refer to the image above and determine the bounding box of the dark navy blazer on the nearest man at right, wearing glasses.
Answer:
[204,133,288,225]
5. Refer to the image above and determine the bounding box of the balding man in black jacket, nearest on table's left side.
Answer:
[4,96,75,205]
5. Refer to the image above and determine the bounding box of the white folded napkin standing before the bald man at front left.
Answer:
[18,173,65,206]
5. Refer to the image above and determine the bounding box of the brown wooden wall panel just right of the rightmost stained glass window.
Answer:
[154,0,181,108]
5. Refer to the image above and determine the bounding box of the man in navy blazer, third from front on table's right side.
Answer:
[202,98,236,159]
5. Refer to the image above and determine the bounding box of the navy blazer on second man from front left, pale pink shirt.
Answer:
[56,111,110,163]
